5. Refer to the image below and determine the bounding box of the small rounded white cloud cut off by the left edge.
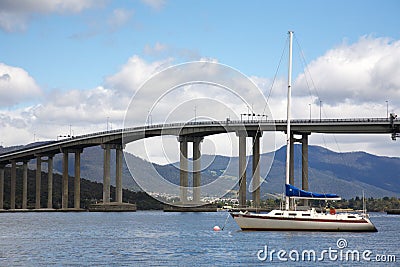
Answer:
[0,63,42,107]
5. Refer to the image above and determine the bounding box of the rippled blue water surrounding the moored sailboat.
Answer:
[0,211,400,266]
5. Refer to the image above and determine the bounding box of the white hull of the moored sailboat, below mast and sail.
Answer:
[231,210,377,232]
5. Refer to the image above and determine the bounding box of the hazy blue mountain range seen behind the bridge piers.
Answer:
[2,145,400,199]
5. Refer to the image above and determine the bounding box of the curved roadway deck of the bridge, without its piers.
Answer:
[0,118,400,164]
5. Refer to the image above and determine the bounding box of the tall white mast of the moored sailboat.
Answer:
[285,31,293,210]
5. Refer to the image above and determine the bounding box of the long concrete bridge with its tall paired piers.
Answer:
[0,117,400,210]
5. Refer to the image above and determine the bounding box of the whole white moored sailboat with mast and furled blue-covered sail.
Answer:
[231,31,377,232]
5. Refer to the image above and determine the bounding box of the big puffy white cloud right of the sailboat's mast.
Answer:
[293,36,400,105]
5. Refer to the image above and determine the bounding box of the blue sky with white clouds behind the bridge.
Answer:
[0,0,400,163]
